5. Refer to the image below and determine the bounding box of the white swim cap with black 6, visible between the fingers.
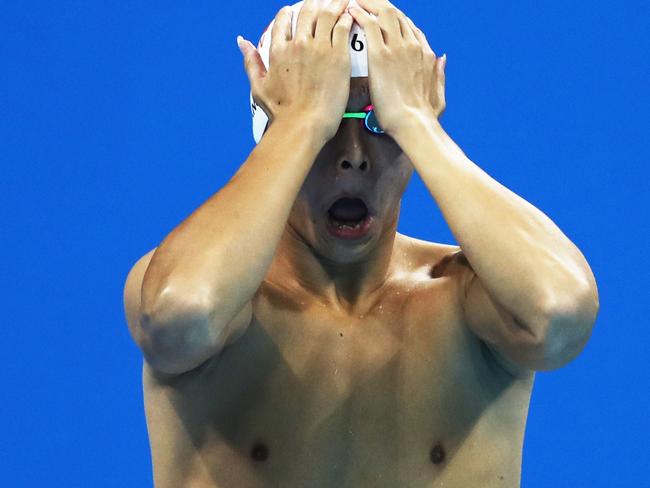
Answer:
[250,0,368,144]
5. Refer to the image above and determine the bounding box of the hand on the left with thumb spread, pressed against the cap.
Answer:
[239,0,352,139]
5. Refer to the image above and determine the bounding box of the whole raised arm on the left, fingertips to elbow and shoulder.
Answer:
[125,0,352,374]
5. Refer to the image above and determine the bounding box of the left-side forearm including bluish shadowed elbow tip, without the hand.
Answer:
[135,116,330,373]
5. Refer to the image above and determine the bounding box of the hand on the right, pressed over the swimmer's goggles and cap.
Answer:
[348,0,446,135]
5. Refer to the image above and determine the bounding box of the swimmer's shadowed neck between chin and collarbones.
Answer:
[269,212,399,313]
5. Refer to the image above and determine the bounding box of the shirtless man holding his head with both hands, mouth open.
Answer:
[124,0,598,488]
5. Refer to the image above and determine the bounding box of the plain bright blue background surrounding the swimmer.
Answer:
[0,0,650,488]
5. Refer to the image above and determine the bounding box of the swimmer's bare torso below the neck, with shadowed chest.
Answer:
[143,234,534,488]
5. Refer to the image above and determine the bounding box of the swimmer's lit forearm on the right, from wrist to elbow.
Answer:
[395,110,595,330]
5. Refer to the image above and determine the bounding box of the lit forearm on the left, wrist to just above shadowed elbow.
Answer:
[142,116,324,323]
